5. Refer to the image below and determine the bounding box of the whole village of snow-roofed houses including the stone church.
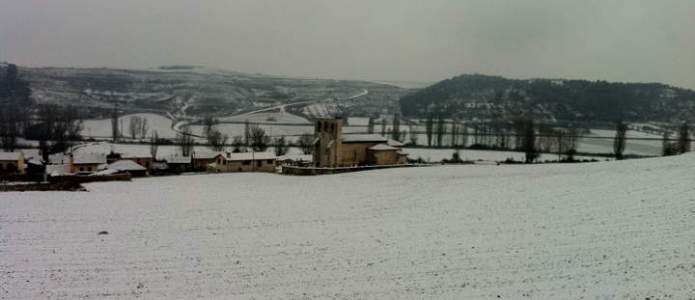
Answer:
[0,118,411,190]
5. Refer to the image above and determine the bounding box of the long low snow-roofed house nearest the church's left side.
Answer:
[208,152,277,172]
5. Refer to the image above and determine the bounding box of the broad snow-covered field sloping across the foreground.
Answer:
[0,155,695,299]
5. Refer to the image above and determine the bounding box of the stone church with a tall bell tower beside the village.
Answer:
[313,118,408,168]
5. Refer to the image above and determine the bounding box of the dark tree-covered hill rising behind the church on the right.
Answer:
[400,75,695,122]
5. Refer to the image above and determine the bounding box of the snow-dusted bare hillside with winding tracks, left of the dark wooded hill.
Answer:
[20,66,403,118]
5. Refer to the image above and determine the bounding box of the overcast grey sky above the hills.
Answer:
[0,0,695,88]
